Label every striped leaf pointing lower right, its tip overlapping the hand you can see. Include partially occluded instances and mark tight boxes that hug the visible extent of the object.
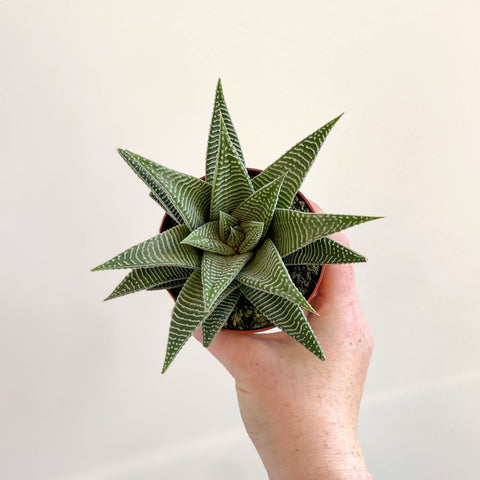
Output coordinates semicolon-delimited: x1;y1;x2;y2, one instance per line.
239;285;325;360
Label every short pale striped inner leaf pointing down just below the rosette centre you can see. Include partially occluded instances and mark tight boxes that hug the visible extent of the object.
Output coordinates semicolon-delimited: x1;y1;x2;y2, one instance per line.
201;252;253;311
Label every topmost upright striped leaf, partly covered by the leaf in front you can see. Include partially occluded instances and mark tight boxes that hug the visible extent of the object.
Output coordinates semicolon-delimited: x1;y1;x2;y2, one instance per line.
205;79;245;184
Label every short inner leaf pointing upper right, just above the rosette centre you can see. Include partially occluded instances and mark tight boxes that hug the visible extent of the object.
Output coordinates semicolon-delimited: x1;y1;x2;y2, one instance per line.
232;177;283;235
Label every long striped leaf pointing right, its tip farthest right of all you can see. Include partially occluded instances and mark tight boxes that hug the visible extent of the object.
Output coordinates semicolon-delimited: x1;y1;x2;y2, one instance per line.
268;209;381;257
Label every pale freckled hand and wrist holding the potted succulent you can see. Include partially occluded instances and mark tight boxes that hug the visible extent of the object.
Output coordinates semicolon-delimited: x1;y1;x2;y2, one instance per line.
195;226;373;480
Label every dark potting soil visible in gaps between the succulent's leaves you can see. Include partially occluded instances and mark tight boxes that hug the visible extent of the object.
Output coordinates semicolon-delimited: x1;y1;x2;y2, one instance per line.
163;194;322;330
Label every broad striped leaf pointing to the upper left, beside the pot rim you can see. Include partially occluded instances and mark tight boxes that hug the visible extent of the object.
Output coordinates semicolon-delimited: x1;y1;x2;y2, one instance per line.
119;150;211;230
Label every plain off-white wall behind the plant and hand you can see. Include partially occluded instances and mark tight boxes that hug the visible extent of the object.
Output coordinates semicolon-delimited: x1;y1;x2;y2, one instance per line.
0;0;480;480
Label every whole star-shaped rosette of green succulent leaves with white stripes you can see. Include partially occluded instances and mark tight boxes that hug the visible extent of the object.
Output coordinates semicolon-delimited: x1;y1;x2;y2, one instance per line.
93;81;379;372
